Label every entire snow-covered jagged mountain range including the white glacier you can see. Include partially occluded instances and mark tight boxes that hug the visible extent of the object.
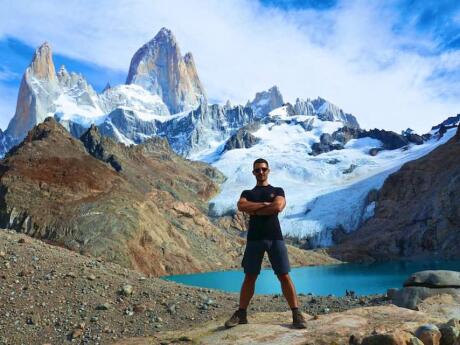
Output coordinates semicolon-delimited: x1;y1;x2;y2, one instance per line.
0;29;452;246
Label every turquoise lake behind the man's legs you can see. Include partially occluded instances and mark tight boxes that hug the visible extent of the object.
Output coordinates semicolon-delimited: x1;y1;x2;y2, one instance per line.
163;260;460;296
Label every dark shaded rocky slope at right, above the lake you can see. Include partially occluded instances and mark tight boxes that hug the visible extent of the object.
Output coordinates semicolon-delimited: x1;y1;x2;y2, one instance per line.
331;125;460;260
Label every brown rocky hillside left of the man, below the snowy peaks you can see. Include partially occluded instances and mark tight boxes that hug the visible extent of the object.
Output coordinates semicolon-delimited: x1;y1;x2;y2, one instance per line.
0;118;243;275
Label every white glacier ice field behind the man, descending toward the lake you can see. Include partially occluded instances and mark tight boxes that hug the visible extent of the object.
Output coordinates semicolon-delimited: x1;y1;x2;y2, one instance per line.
204;113;455;247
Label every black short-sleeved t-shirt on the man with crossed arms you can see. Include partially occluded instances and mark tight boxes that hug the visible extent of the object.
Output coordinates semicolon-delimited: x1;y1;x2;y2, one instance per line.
241;185;284;241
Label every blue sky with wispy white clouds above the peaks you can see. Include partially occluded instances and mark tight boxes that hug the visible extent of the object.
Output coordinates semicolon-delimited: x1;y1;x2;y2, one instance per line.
0;0;460;132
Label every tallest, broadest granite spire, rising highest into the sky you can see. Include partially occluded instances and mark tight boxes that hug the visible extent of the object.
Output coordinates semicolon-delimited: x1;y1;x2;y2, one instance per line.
126;28;206;114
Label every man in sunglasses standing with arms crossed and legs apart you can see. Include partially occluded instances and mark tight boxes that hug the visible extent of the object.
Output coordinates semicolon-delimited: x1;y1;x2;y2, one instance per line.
225;158;306;328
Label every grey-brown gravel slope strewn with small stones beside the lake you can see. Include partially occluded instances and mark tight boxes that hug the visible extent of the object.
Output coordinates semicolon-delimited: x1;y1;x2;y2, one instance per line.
0;230;389;344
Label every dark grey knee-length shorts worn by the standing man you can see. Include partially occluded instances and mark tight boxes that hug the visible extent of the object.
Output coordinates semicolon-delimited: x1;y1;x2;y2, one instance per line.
241;240;291;275
